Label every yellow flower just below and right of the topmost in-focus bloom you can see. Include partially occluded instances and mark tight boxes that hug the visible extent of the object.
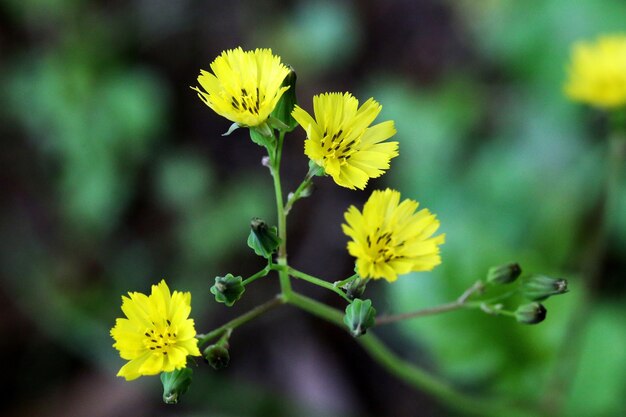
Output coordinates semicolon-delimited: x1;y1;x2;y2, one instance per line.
292;93;398;190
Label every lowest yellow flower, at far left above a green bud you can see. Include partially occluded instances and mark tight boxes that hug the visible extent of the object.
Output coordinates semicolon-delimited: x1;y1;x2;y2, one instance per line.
111;280;200;381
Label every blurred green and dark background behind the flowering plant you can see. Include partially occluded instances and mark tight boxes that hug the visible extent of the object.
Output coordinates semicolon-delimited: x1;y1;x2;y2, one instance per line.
0;0;626;417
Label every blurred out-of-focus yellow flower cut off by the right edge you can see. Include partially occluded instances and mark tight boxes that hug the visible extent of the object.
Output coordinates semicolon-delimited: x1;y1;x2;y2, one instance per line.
565;35;626;109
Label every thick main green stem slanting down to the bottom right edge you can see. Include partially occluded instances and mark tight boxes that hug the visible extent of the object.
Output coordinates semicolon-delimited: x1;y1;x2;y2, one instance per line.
285;293;533;417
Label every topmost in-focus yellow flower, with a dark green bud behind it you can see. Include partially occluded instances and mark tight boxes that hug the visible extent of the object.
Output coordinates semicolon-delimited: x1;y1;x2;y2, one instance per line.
192;48;289;127
